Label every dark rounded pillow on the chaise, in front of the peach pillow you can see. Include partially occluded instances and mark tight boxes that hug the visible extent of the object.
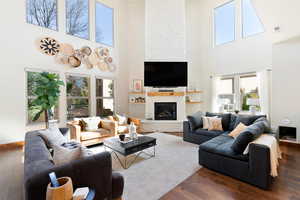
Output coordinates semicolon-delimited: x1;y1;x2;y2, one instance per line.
231;130;254;154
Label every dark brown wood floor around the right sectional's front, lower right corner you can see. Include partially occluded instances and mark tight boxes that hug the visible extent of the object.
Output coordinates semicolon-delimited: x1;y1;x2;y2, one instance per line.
161;145;300;200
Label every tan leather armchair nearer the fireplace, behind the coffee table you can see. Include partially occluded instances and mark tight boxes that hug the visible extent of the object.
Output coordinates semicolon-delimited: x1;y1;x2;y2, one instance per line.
108;116;142;134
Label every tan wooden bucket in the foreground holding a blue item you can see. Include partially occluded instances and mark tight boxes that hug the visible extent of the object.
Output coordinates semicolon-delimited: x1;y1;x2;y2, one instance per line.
46;177;73;200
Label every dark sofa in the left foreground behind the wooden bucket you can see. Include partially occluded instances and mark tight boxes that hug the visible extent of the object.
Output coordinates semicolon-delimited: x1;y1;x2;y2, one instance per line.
24;129;124;200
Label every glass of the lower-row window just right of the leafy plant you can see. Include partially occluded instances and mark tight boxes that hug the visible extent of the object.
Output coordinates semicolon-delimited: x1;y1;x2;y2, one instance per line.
66;75;90;119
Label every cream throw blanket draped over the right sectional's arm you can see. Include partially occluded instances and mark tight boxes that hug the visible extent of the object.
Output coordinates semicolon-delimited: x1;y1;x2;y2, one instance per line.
243;134;281;177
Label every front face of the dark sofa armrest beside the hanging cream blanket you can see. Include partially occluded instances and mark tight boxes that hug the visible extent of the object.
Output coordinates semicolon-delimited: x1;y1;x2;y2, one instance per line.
249;143;271;189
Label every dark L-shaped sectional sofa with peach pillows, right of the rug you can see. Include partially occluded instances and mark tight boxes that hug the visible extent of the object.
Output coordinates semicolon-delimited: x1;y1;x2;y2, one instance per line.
184;113;272;189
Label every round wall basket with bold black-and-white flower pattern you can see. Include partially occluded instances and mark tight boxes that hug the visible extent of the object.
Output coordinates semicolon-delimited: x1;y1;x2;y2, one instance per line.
39;37;60;56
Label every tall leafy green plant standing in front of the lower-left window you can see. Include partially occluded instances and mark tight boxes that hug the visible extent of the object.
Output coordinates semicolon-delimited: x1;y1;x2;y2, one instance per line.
29;72;64;128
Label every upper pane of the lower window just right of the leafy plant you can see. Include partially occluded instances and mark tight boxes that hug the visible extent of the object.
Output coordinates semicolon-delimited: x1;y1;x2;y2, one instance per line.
67;76;89;97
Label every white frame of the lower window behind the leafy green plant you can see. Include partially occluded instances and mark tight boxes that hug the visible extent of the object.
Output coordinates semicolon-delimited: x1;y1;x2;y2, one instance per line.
24;68;60;126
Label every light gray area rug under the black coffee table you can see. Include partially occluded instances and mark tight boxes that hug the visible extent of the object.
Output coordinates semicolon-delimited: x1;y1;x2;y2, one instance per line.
91;133;200;200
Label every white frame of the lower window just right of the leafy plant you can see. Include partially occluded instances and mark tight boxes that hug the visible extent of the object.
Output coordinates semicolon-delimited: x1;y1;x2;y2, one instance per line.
65;73;92;121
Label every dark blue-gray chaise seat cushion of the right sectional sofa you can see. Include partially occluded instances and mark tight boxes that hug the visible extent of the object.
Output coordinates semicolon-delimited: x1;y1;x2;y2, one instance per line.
199;134;249;161
